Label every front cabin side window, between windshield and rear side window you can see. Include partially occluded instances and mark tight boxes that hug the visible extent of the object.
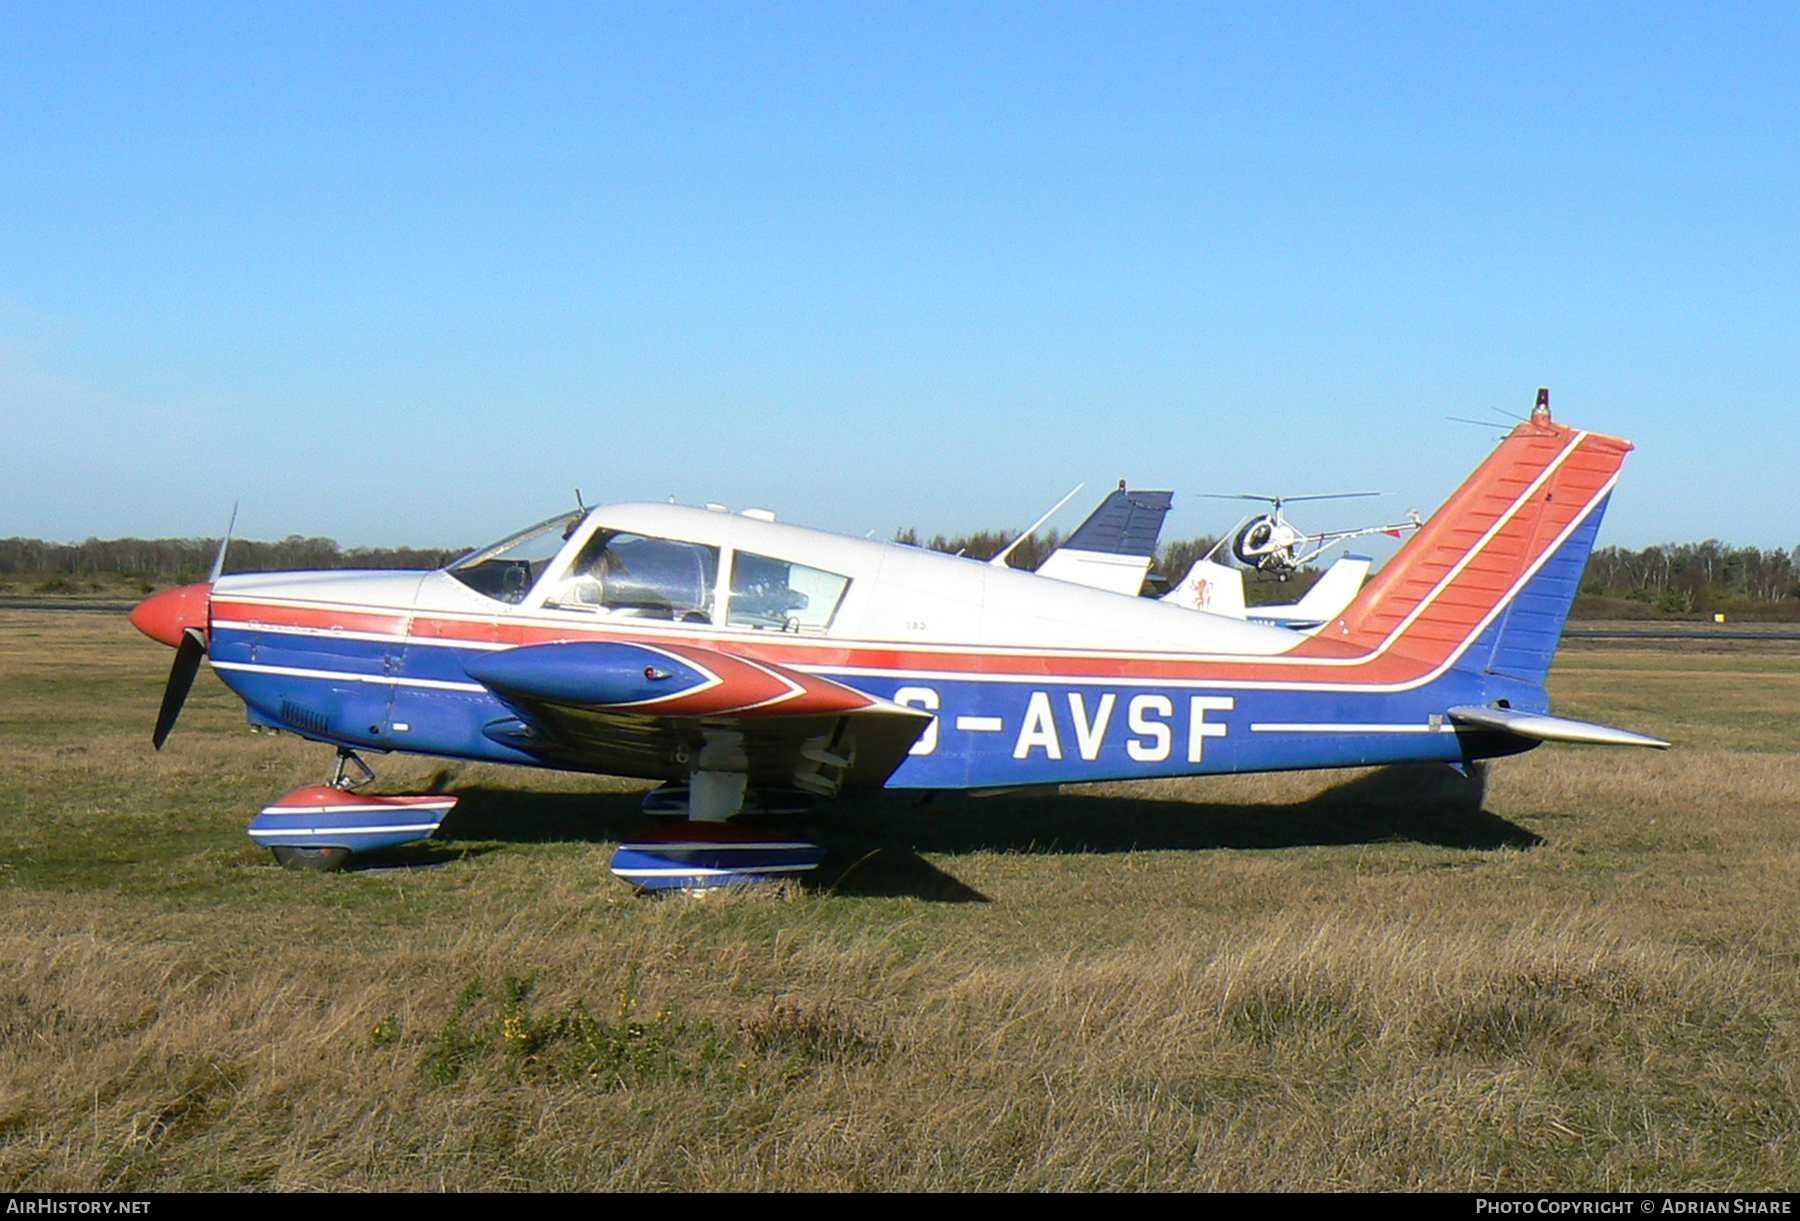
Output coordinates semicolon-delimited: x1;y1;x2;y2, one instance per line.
544;531;718;623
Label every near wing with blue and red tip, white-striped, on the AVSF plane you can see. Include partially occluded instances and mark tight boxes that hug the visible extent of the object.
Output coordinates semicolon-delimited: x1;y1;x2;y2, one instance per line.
466;641;931;794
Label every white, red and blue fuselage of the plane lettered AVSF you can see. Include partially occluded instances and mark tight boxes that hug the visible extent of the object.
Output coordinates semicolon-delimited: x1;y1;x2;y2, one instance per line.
209;499;1576;789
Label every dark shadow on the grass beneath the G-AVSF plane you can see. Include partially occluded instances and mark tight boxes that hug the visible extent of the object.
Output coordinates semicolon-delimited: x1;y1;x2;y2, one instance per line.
409;765;1544;902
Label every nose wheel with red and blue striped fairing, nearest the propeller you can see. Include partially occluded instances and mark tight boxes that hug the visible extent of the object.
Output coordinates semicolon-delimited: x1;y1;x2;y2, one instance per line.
250;747;455;870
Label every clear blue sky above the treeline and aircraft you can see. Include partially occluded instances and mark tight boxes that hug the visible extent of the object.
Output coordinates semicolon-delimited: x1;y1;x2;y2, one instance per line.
0;4;1800;546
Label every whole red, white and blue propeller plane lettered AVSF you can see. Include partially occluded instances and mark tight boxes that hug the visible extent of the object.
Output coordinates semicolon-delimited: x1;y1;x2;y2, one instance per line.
131;391;1667;888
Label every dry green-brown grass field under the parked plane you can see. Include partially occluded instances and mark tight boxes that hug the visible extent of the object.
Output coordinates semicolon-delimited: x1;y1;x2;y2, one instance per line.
0;611;1800;1190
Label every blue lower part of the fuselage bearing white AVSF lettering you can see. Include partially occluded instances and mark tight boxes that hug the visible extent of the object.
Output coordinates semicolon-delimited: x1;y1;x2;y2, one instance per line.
211;615;1548;789
